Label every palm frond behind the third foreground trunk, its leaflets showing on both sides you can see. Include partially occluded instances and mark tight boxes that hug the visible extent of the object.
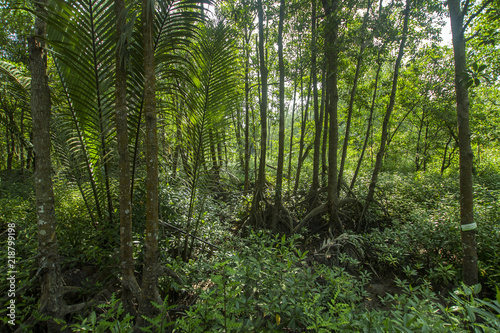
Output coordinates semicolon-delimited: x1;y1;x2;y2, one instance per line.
128;0;209;197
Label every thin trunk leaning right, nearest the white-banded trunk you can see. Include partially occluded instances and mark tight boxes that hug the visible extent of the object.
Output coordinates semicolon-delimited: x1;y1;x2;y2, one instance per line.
358;0;411;232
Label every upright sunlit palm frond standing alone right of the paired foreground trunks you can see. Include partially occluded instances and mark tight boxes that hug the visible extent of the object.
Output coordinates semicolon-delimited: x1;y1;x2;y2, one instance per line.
176;22;238;257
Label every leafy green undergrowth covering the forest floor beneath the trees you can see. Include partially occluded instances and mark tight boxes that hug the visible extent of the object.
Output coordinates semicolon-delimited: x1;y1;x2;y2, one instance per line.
0;166;500;332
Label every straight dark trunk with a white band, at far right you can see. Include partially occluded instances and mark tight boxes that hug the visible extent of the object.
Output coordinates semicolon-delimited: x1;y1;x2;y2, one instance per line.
448;0;478;286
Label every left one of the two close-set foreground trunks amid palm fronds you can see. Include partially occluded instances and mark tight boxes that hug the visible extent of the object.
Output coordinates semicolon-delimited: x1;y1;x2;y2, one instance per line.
115;0;140;313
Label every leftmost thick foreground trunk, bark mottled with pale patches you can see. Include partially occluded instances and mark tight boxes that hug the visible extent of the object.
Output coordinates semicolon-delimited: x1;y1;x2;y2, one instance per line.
29;0;65;326
